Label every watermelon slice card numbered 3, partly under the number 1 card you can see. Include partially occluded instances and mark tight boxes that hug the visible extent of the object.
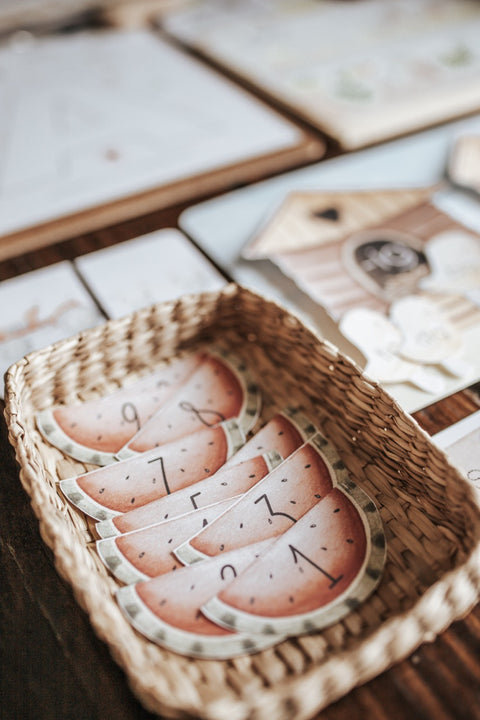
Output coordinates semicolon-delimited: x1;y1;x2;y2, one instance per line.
175;433;347;565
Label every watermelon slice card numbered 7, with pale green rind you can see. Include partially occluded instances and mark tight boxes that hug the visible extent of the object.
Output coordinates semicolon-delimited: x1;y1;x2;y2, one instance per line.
60;420;245;520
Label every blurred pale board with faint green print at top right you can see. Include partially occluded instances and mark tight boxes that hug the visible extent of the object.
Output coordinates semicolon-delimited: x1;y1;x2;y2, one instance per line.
165;0;480;149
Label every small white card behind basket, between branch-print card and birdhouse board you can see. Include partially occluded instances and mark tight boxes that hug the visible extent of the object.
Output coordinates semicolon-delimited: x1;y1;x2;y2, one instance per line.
75;229;227;318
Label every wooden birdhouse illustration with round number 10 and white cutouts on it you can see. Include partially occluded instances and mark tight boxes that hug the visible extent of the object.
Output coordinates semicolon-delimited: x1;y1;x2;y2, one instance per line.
244;188;480;401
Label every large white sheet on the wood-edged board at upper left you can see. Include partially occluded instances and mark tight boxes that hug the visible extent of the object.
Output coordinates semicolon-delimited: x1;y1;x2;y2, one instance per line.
0;31;301;235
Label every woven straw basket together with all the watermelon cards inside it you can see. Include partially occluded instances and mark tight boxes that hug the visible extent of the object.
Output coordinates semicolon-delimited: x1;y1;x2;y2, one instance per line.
5;285;480;720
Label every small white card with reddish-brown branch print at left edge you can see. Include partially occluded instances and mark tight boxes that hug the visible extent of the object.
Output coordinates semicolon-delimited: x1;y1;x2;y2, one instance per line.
0;262;104;395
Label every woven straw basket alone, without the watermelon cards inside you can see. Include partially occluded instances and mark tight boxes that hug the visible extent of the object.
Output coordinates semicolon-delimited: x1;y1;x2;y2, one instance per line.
6;285;480;720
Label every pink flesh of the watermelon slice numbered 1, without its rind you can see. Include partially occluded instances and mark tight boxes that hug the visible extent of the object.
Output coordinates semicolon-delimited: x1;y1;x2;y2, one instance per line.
219;488;367;617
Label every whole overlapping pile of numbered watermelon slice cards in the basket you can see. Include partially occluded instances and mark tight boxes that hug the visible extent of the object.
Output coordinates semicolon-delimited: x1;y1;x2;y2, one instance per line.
37;348;385;658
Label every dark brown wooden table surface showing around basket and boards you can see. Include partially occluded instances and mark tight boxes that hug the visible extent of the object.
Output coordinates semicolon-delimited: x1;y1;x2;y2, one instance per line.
0;143;480;720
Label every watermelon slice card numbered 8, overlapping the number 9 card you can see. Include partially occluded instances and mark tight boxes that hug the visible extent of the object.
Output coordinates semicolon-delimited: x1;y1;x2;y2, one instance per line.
117;350;260;459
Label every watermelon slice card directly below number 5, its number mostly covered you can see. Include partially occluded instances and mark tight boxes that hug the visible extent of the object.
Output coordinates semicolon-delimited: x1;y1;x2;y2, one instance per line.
97;498;234;585
